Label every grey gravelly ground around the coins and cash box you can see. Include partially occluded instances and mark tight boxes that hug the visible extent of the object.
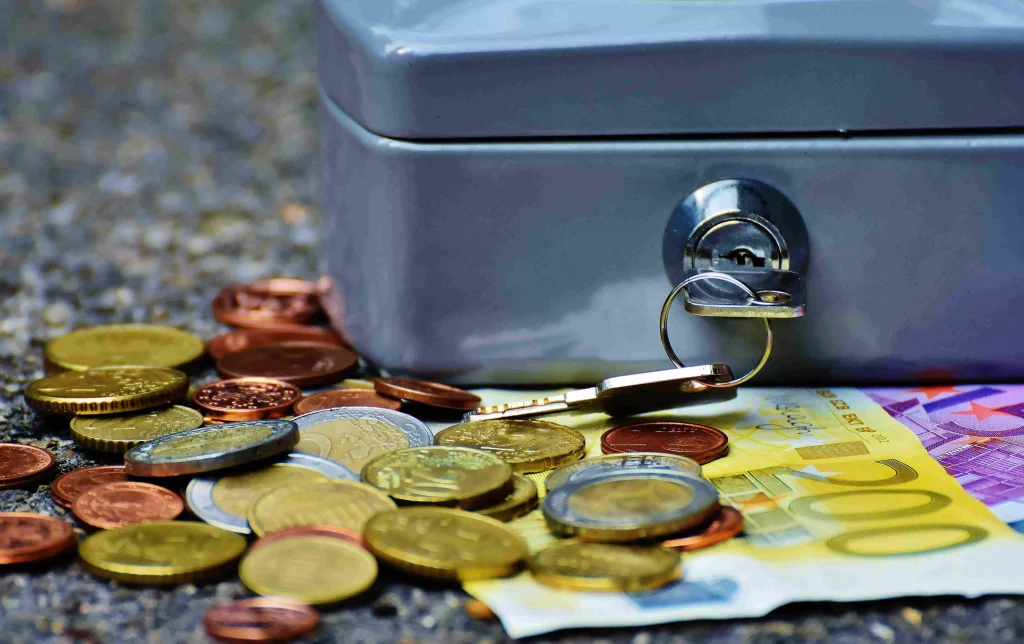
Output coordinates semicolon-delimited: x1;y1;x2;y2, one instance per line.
0;0;1024;644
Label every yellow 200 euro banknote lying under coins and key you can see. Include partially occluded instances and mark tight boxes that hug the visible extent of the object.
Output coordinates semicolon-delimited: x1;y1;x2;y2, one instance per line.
465;388;1024;638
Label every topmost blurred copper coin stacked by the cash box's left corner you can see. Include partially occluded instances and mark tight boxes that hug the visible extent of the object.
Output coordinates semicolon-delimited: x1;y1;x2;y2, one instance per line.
213;277;323;330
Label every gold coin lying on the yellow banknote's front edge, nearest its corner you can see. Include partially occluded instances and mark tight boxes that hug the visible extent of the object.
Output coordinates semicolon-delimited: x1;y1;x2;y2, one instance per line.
526;541;683;593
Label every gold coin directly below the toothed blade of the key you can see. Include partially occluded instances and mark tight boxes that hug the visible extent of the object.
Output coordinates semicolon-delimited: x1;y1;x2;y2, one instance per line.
434;419;586;473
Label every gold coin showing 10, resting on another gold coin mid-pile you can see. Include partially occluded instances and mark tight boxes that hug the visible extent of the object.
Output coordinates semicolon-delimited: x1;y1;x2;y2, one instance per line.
361;445;512;510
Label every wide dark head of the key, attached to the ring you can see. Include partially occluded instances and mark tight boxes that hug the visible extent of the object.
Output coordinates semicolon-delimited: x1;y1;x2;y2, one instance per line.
596;364;736;416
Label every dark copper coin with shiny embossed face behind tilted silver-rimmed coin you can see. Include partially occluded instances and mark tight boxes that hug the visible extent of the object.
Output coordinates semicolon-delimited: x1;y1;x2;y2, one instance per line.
193;378;302;421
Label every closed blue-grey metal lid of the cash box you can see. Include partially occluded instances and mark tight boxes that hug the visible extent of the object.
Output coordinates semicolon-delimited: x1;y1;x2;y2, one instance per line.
317;0;1024;139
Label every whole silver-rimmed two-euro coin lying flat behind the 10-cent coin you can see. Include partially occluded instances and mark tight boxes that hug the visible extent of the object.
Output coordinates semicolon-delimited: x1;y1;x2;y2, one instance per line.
292;407;434;473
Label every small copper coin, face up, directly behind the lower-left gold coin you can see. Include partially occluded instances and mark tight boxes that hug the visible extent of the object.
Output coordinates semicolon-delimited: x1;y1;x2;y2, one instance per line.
71;481;185;530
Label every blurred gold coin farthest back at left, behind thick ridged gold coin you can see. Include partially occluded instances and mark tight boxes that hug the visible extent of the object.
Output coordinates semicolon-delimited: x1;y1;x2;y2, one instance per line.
45;325;204;371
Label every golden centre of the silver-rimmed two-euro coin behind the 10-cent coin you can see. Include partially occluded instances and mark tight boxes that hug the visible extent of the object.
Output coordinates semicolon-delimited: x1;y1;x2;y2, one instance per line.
295;418;409;472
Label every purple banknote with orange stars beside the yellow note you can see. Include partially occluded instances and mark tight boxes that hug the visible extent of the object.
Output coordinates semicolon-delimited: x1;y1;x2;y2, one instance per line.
864;385;1024;532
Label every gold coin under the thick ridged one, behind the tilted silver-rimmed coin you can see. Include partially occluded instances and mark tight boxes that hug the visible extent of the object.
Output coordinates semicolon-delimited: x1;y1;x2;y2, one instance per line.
71;404;203;454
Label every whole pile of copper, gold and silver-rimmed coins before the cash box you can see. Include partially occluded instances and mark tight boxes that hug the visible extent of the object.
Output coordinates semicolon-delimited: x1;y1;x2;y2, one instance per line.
0;280;742;641
